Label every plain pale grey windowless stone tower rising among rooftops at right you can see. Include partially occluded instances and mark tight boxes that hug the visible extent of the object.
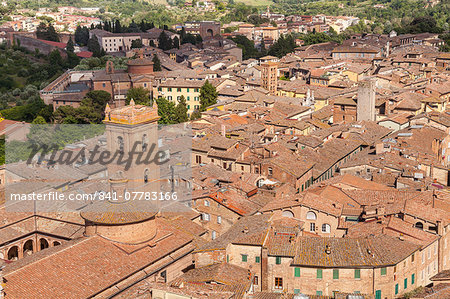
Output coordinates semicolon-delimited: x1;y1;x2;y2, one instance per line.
356;79;376;121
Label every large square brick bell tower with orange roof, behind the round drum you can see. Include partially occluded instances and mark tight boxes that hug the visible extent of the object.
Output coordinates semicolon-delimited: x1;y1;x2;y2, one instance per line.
103;100;160;193
